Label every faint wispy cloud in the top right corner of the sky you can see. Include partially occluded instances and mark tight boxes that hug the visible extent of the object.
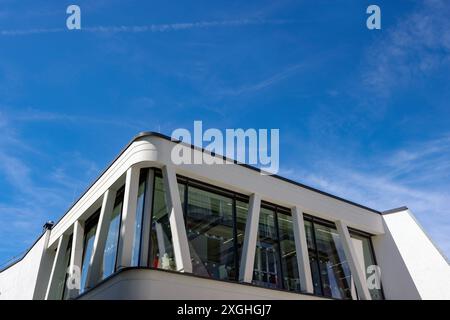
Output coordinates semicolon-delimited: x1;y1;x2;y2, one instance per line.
362;0;450;97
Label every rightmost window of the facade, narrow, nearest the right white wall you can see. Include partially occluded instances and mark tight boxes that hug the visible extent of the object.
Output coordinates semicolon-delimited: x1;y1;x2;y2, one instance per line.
350;232;384;300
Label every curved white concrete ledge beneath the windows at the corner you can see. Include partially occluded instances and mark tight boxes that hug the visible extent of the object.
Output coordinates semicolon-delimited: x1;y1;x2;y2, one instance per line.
78;268;328;300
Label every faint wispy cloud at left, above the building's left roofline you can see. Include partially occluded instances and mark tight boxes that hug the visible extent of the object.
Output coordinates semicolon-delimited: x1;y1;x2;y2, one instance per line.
0;112;99;266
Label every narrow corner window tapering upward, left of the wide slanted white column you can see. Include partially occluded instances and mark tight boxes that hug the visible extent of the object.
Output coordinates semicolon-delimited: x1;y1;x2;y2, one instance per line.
149;175;176;270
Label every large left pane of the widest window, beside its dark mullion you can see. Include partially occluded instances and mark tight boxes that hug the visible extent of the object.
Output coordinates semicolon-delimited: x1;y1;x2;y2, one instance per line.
186;186;237;280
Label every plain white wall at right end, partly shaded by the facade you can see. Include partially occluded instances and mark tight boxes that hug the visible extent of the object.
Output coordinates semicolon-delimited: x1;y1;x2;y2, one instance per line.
373;209;450;300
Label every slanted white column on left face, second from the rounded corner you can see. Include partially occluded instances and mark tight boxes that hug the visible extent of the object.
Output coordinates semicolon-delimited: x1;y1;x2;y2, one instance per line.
86;189;117;288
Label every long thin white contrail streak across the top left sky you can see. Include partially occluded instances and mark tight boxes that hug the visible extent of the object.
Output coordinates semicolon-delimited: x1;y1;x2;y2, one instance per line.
0;19;293;36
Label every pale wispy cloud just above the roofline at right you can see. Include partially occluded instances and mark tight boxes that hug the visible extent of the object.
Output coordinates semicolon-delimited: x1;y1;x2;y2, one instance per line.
282;136;450;257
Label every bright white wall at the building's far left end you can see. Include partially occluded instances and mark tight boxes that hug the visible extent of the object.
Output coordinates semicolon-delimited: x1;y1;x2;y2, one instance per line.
0;235;46;300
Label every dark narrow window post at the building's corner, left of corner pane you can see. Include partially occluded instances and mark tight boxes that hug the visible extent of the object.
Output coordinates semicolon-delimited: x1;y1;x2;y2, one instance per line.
139;169;155;267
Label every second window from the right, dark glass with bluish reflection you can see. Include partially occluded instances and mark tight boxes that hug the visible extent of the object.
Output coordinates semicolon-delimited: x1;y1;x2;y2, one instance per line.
305;219;354;299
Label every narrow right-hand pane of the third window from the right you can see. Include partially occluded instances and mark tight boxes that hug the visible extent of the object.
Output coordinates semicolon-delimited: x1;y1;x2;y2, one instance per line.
277;212;301;292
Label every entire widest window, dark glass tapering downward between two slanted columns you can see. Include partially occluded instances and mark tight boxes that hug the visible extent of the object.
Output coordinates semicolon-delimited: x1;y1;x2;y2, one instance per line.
178;178;248;281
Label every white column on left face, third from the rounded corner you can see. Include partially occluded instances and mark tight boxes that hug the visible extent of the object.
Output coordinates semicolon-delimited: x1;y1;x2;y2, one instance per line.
68;220;84;299
